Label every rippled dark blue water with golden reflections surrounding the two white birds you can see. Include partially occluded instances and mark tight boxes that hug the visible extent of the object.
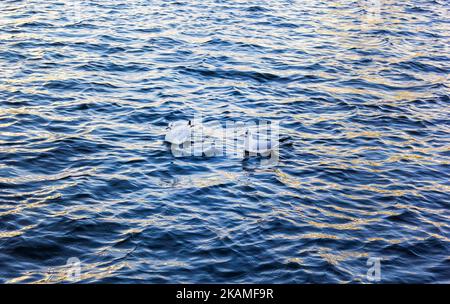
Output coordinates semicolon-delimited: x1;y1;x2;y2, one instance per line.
0;0;450;283
